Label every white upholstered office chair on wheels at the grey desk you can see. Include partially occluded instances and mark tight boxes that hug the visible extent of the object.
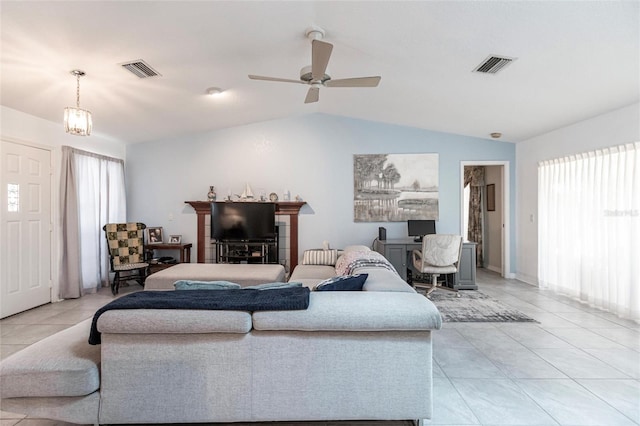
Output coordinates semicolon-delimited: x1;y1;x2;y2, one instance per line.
412;234;462;297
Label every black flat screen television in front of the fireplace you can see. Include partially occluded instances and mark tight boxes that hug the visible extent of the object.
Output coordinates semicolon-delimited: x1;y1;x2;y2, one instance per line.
211;202;276;241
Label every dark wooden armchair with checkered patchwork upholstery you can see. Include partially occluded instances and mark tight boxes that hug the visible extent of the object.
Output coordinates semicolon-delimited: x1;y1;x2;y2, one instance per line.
102;222;149;296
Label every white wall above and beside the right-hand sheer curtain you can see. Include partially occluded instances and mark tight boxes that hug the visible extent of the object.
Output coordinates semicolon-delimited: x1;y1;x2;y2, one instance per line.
516;104;640;284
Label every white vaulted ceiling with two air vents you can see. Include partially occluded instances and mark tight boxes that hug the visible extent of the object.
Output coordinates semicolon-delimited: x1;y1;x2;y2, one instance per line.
0;1;640;143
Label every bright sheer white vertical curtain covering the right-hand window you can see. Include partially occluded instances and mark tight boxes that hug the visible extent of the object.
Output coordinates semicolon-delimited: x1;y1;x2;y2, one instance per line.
538;142;640;322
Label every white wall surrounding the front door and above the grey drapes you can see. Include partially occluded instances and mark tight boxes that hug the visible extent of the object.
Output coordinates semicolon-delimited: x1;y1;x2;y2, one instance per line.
0;105;126;300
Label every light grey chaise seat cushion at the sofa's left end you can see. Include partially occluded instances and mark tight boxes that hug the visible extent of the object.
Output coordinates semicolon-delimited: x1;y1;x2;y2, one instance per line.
0;319;100;398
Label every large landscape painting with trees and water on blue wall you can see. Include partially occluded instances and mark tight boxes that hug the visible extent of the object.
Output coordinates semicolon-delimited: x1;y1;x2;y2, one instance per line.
353;154;438;222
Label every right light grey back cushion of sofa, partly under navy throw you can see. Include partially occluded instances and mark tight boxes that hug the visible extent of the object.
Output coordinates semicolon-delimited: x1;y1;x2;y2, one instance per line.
252;291;442;331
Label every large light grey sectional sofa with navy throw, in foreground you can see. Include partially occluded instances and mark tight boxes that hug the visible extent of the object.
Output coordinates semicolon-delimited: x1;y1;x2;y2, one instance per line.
0;245;441;424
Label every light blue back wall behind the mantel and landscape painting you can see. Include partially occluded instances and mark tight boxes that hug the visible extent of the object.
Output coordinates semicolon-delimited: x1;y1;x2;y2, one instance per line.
126;114;516;271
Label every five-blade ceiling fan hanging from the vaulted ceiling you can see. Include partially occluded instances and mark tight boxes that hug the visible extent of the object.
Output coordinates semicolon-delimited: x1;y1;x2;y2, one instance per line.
249;27;381;104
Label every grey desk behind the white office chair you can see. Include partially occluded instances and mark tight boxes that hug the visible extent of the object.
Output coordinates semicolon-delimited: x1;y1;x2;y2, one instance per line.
373;238;478;290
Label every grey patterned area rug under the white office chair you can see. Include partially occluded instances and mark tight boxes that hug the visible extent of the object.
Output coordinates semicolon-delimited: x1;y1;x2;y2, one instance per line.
418;289;538;322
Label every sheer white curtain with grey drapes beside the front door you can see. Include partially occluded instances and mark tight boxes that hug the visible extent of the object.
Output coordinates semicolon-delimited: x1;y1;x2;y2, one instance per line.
60;147;126;298
